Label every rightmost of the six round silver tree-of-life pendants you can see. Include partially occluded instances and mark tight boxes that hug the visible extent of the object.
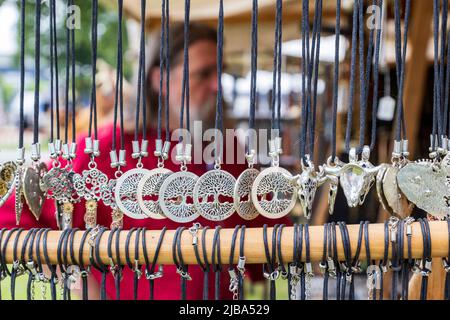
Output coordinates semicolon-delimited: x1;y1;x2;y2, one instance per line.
252;167;297;219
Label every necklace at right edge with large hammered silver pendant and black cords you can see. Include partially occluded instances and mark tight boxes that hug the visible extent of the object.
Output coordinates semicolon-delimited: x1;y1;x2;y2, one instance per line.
397;0;450;218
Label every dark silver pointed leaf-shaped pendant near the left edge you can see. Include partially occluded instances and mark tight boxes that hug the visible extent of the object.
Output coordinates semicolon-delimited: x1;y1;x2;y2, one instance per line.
23;162;47;220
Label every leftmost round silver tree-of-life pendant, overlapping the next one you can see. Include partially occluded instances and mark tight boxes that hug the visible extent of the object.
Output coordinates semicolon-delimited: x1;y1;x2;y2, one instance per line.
114;168;149;220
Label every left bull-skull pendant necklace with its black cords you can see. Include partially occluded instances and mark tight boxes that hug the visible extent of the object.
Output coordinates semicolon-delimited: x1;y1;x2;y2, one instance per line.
292;0;338;219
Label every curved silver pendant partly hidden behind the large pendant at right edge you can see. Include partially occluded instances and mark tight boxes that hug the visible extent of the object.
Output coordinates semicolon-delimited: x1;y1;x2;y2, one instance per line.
377;165;414;218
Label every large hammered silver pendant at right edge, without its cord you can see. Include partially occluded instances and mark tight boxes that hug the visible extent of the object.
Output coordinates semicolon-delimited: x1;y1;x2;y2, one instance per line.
397;160;450;218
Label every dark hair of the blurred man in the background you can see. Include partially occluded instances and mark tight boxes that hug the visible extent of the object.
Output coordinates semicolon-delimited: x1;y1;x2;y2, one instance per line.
146;22;217;124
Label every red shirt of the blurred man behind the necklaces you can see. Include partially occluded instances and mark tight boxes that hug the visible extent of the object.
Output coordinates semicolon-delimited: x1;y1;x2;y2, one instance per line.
0;126;290;300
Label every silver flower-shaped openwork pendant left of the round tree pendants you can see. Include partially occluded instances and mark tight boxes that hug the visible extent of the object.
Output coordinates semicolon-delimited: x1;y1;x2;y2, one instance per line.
72;167;108;201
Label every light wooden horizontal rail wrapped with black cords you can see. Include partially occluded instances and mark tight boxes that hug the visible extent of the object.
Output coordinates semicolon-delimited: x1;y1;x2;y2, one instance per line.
2;221;449;265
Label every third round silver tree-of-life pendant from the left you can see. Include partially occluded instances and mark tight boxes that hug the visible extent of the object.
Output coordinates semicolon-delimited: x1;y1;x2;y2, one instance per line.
158;171;200;223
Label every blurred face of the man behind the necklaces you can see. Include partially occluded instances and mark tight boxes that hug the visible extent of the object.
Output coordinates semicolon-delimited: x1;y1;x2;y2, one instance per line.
170;40;217;129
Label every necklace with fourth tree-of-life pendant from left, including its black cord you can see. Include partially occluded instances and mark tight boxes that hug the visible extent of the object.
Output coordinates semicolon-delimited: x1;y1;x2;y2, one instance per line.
194;0;236;221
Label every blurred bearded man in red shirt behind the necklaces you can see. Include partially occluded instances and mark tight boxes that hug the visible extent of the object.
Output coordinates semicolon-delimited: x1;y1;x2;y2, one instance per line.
0;23;289;300
